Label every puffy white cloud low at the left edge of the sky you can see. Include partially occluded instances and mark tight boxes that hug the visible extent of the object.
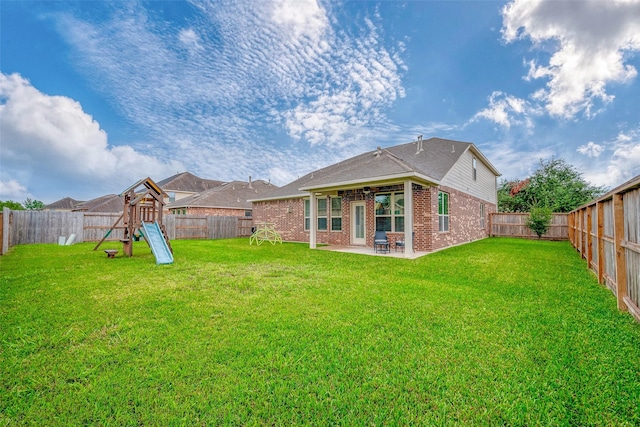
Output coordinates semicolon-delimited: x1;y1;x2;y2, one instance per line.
0;73;183;201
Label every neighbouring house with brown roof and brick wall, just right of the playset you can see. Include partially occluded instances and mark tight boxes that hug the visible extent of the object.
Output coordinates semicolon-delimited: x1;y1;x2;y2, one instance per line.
165;177;278;218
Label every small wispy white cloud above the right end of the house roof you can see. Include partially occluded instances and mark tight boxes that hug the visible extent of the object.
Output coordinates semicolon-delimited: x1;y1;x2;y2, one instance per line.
471;91;540;129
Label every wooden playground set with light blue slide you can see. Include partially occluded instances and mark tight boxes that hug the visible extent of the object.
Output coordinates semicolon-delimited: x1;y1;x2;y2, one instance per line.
93;178;173;264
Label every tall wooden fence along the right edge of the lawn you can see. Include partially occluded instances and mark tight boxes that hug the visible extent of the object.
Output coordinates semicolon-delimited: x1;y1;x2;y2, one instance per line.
569;175;640;322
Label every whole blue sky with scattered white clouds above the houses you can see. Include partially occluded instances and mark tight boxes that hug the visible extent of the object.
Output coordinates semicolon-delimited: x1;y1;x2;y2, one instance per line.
0;0;640;203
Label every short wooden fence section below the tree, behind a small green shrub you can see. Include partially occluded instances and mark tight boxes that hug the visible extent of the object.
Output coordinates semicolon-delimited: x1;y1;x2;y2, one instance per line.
489;212;569;240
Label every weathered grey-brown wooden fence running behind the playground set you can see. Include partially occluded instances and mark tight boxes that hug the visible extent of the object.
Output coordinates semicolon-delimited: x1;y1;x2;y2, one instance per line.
0;208;252;254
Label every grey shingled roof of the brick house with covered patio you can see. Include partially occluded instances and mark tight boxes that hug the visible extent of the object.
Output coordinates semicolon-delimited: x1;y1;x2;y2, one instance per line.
253;138;500;201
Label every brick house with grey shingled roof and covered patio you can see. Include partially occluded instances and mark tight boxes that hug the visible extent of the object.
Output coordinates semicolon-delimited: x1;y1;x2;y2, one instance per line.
252;137;500;256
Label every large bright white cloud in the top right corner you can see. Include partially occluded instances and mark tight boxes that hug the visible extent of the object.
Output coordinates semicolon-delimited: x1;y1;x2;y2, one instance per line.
502;0;640;118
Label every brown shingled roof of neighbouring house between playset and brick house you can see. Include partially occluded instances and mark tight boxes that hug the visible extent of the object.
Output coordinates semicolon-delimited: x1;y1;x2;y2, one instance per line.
165;180;277;209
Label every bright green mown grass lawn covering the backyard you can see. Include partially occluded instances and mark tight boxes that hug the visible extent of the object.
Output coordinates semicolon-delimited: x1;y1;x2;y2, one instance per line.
0;239;640;426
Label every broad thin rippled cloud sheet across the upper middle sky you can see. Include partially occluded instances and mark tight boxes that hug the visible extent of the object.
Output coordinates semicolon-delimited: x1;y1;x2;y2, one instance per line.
57;0;406;154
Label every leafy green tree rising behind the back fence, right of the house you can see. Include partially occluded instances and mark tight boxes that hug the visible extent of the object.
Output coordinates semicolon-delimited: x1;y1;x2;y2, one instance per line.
498;159;607;212
